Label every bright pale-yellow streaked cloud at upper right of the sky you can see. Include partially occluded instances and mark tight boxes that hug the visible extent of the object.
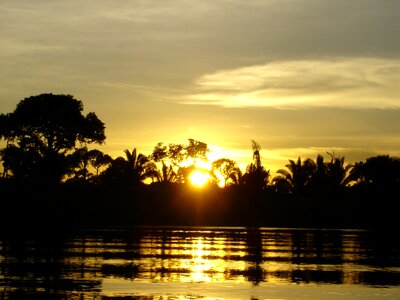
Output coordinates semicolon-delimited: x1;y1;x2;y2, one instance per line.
182;58;400;108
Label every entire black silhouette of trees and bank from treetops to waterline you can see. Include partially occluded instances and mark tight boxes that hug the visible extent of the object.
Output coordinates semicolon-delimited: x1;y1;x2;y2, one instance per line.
0;94;400;229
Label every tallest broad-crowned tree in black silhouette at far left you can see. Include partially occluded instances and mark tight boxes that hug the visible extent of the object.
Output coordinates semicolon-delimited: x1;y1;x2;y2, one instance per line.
0;94;105;183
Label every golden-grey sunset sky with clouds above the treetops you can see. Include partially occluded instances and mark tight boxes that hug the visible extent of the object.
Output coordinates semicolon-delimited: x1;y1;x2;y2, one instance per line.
0;0;400;172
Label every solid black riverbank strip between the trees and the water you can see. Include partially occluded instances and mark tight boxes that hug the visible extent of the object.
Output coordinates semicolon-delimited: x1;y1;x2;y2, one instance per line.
0;180;400;231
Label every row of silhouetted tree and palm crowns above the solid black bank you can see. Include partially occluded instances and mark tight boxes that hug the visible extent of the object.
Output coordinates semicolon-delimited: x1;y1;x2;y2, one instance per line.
0;94;400;195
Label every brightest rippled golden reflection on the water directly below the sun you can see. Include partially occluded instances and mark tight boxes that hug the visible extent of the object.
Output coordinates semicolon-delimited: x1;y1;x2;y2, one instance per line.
140;234;246;282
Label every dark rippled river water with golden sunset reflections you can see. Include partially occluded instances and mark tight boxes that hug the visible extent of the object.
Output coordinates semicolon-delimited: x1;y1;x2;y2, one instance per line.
0;227;400;300
